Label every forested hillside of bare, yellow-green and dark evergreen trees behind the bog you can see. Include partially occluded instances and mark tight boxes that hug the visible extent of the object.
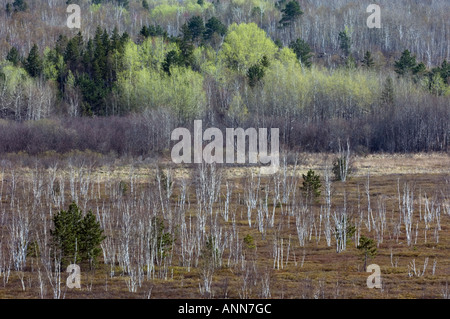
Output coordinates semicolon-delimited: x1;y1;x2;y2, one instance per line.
0;0;450;156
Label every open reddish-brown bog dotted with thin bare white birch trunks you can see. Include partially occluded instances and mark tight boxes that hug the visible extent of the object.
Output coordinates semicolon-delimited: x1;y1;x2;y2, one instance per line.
0;153;450;299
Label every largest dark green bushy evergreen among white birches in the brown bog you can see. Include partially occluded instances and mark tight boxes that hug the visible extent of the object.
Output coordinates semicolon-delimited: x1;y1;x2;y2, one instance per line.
50;203;106;267
